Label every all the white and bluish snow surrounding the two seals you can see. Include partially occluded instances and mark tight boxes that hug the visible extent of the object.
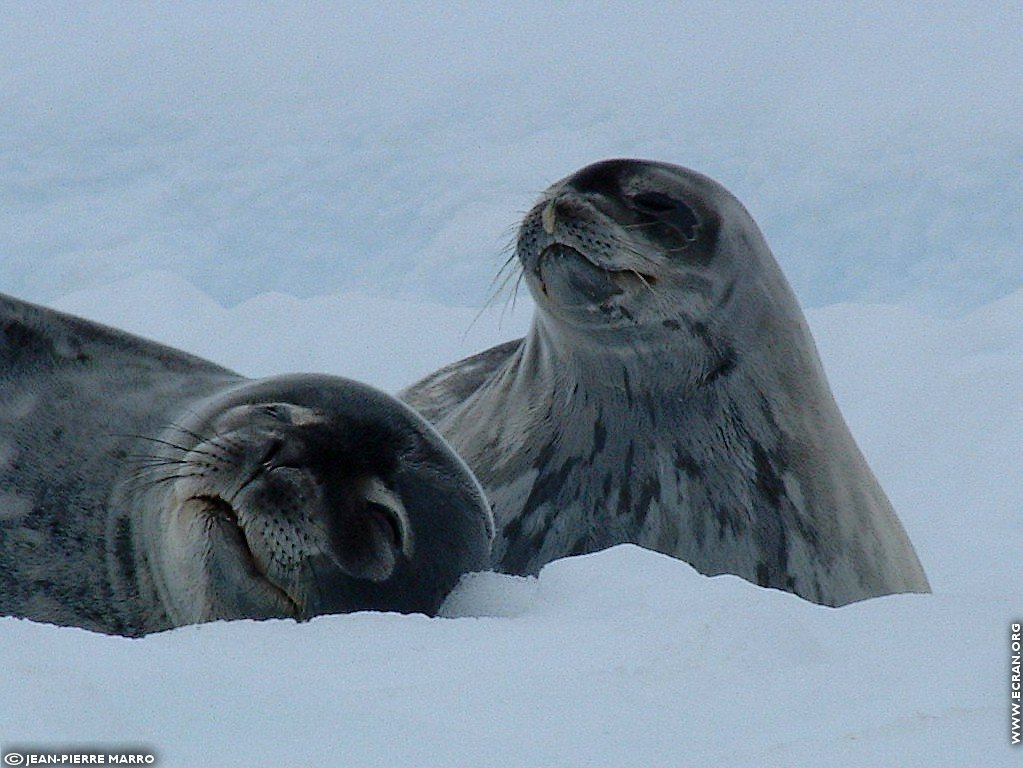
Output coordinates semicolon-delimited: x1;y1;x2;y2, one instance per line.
0;2;1023;768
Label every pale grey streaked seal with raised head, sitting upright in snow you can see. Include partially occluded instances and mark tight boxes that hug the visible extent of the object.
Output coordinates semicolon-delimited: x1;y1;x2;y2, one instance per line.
399;160;930;605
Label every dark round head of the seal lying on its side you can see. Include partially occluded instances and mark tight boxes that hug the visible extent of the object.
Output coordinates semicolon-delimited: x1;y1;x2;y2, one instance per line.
110;375;492;625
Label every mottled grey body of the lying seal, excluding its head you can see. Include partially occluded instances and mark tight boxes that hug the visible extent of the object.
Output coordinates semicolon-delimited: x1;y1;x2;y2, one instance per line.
0;295;243;632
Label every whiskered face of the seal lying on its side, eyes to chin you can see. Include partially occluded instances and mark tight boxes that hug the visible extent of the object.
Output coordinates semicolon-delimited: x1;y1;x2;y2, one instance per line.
155;403;427;618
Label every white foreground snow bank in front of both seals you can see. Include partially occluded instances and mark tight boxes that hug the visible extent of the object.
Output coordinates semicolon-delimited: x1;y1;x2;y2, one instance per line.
2;546;1009;766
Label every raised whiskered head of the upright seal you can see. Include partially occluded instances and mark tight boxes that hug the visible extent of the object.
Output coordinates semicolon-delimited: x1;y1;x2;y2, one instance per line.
517;161;720;346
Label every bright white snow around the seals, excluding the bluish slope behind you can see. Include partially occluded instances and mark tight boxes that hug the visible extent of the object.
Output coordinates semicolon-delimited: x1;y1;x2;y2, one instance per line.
0;274;1023;768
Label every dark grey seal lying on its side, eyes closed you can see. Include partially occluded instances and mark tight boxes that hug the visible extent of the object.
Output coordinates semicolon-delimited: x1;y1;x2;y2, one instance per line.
0;296;493;636
